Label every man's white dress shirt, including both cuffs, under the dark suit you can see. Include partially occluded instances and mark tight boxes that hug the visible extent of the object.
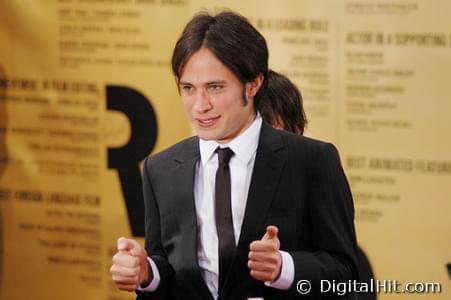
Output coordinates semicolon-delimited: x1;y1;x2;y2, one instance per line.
140;114;294;299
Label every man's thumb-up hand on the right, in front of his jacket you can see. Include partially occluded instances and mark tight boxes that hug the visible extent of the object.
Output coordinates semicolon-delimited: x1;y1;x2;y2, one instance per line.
247;225;282;282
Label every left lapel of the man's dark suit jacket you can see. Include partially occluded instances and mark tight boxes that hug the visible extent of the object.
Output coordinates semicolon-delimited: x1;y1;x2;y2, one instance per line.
172;138;216;299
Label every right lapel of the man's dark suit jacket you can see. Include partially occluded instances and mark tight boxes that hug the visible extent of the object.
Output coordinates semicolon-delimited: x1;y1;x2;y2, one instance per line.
224;122;283;290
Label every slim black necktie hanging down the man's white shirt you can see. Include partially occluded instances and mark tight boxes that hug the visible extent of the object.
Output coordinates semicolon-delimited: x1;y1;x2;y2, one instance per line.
215;147;235;291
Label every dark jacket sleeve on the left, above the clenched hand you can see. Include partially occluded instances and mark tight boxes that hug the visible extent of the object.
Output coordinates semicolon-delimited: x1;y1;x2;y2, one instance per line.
137;158;174;300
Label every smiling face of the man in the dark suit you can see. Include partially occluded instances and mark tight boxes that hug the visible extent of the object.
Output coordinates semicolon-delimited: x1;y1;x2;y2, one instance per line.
179;48;262;143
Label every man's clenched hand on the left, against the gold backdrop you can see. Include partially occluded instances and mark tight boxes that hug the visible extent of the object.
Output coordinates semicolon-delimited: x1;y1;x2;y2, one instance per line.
110;237;153;291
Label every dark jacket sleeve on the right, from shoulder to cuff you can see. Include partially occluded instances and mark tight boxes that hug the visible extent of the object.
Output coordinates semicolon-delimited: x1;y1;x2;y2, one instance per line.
290;144;358;296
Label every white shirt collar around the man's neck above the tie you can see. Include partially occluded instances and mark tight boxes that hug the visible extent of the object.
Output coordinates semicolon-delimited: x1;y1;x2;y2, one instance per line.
199;113;262;165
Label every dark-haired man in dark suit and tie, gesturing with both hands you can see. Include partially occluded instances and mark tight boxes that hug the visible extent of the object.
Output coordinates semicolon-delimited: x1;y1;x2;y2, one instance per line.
111;13;357;299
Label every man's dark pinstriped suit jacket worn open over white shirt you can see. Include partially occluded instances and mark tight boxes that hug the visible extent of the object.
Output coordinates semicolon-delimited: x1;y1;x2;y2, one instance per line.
138;123;358;299
